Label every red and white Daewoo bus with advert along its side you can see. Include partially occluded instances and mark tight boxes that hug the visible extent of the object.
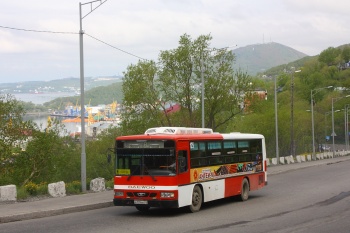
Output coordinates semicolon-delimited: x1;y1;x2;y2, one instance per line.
113;127;267;212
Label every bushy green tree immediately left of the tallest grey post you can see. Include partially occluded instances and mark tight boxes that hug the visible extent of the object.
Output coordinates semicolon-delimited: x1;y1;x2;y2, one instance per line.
13;118;77;185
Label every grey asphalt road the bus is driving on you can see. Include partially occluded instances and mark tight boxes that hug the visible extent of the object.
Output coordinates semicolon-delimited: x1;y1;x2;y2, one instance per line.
0;160;350;233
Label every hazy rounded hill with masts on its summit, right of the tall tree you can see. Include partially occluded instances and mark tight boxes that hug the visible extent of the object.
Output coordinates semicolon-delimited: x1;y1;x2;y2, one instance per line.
232;42;308;76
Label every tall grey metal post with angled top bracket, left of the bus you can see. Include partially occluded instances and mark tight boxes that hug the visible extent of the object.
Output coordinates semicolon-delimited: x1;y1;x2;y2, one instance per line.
79;0;107;192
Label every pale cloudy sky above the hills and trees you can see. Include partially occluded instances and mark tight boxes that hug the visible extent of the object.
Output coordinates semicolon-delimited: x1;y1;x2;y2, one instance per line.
0;0;350;83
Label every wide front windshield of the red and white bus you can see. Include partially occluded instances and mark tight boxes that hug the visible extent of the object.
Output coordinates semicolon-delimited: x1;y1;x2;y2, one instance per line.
116;148;176;177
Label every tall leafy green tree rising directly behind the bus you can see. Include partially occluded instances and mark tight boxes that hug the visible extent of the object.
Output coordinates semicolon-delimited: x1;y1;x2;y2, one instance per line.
123;34;251;132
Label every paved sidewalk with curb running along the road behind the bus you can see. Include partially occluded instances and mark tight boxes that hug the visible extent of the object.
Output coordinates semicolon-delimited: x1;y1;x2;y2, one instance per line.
0;156;350;224
